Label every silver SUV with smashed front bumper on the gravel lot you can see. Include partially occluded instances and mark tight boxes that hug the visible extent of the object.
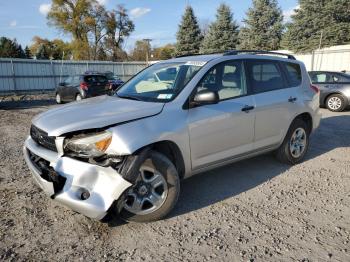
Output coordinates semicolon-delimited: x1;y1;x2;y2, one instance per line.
24;51;320;222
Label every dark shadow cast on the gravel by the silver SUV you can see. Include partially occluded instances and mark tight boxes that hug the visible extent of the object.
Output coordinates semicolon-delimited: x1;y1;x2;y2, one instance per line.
170;115;350;217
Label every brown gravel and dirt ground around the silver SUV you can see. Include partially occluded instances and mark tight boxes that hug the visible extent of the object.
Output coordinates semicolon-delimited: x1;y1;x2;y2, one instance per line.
0;101;350;261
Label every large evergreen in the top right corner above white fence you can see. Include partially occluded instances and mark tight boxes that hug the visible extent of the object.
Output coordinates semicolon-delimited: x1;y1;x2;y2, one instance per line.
282;0;350;52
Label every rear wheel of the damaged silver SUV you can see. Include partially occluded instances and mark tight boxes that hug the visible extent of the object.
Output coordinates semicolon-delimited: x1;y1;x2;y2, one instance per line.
276;118;310;165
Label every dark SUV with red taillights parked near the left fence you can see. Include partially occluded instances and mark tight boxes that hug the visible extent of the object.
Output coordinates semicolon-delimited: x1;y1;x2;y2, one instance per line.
56;74;110;104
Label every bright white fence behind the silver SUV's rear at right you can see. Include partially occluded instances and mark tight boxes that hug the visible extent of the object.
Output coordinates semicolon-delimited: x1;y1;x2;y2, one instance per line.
279;45;350;72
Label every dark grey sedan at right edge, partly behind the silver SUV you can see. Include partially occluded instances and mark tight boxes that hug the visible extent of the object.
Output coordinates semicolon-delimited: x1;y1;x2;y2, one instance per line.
309;71;350;112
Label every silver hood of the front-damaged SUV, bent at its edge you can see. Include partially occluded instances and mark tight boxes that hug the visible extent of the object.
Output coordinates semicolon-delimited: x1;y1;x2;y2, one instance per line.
33;96;164;136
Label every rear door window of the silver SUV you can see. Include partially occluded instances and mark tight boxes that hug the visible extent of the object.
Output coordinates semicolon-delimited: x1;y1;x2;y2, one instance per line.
247;60;285;93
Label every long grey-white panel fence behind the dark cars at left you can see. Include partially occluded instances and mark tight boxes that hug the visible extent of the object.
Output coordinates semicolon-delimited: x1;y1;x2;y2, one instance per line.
0;58;146;94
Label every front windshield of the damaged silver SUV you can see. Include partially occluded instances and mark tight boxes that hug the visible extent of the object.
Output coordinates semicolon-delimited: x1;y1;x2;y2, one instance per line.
117;62;204;102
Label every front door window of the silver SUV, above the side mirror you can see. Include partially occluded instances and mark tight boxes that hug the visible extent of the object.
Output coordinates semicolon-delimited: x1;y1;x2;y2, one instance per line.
197;61;247;100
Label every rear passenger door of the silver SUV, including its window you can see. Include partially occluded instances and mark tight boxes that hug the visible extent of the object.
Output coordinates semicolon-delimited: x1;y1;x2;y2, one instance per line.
247;59;302;150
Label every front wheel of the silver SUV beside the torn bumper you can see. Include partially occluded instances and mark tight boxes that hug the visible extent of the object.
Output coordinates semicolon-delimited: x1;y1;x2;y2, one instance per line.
118;150;180;222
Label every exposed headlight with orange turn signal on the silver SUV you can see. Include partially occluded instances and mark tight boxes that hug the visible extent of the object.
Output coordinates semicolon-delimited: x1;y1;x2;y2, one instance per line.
64;131;112;157
